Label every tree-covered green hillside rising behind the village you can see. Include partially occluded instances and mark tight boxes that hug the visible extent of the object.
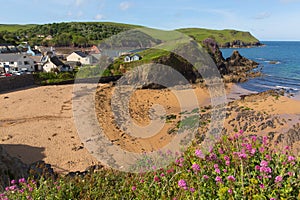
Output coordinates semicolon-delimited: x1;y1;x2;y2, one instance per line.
0;22;139;47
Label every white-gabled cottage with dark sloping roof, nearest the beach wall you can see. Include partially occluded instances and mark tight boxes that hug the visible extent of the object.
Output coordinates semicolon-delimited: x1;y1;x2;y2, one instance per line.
42;56;72;72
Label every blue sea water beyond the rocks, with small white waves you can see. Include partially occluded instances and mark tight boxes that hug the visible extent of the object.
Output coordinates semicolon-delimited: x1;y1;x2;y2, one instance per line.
221;41;300;93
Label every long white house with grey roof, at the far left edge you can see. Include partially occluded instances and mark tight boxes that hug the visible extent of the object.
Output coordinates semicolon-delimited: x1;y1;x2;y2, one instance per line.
0;53;35;72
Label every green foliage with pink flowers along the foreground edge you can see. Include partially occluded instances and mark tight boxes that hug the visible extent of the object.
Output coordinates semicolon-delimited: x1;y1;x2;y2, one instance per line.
0;131;300;200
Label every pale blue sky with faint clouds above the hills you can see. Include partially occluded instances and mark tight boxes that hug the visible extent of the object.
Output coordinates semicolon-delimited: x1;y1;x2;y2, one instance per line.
0;0;300;41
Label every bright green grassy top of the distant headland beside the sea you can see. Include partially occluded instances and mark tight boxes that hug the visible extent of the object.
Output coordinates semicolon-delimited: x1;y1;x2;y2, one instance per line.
177;28;259;45
